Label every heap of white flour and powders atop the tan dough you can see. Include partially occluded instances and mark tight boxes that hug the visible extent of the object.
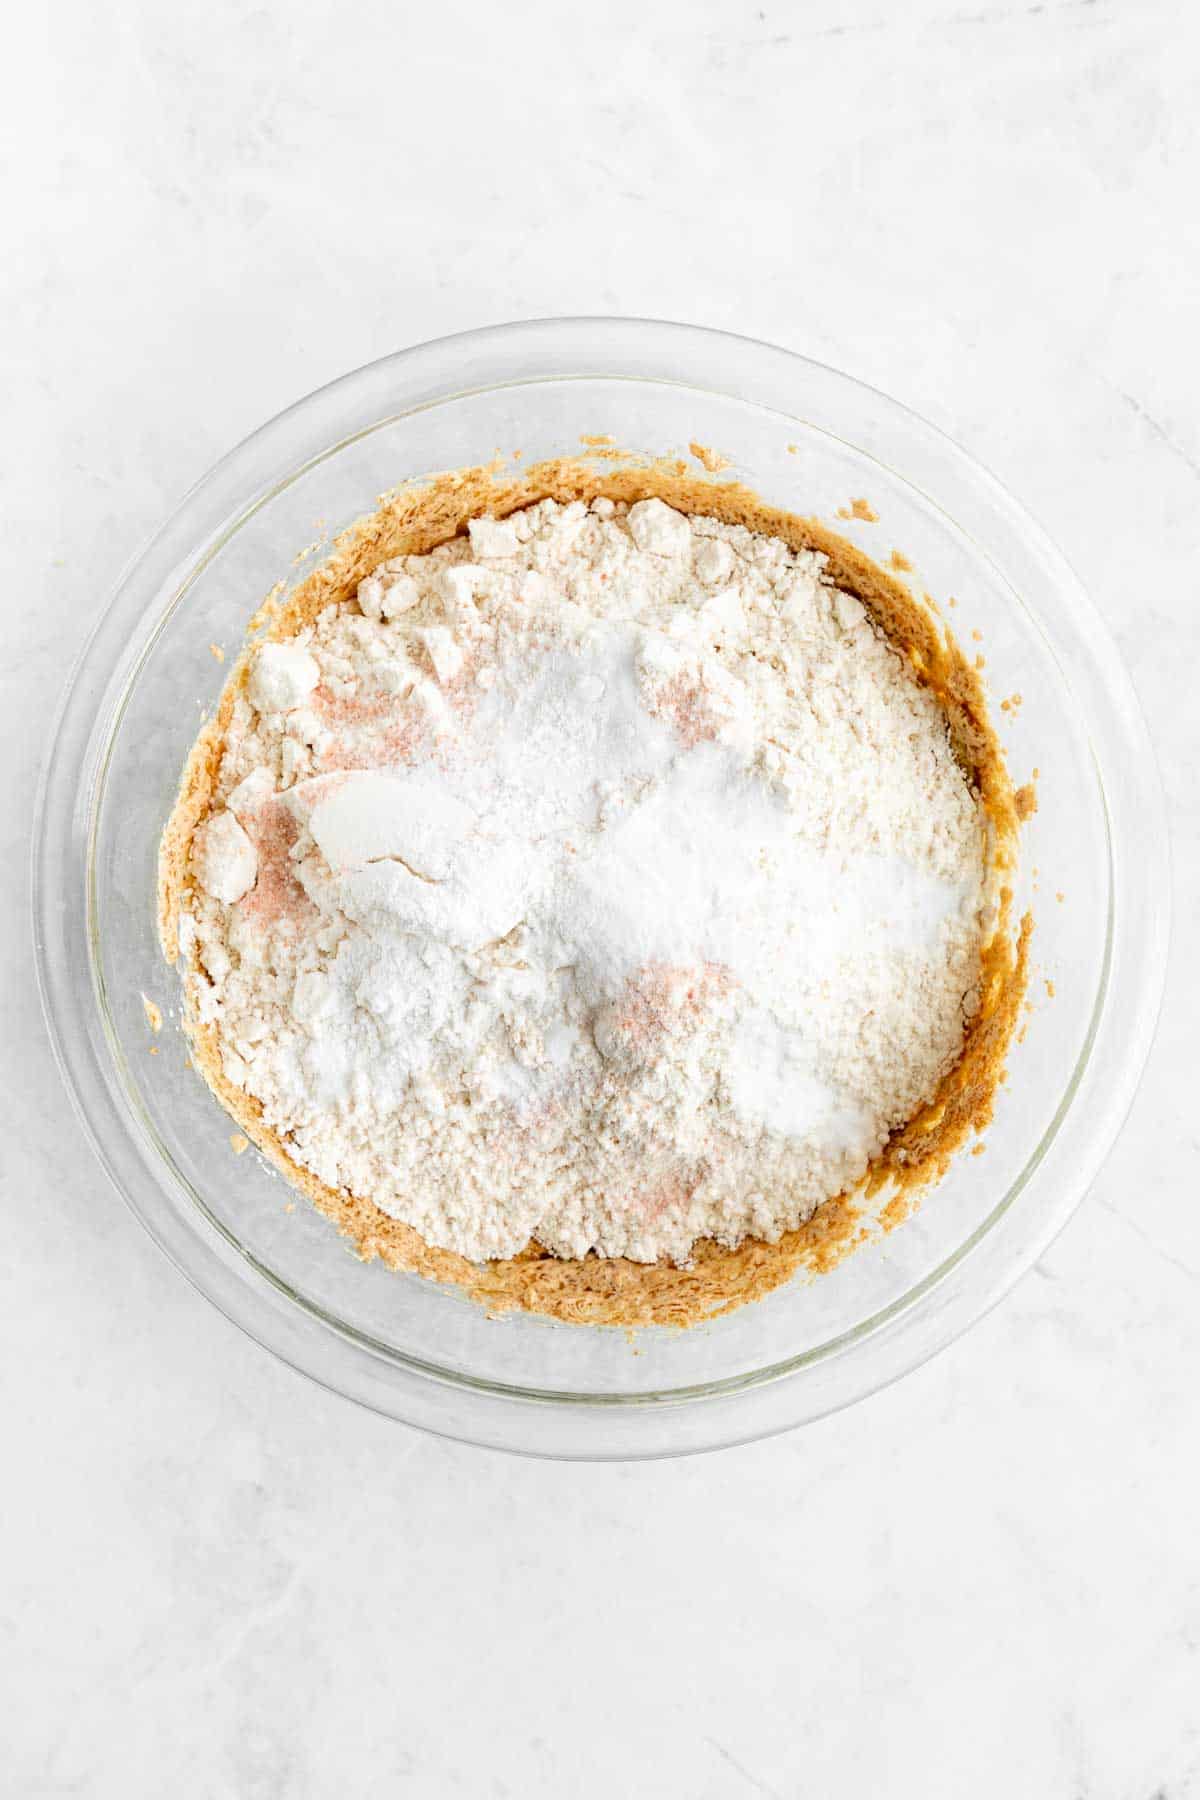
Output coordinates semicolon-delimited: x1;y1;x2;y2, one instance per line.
182;500;986;1262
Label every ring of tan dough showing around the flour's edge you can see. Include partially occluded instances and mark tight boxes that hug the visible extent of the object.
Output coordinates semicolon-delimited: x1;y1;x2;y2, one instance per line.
158;445;1031;1327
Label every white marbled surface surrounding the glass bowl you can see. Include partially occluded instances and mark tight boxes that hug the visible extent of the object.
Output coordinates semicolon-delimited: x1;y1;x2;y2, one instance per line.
9;0;1200;1800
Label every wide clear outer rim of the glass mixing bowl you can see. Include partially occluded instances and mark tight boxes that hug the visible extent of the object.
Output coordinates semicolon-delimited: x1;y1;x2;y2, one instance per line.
31;317;1169;1458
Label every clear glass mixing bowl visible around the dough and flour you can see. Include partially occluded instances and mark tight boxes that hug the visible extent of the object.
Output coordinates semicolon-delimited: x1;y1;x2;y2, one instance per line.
34;319;1168;1458
